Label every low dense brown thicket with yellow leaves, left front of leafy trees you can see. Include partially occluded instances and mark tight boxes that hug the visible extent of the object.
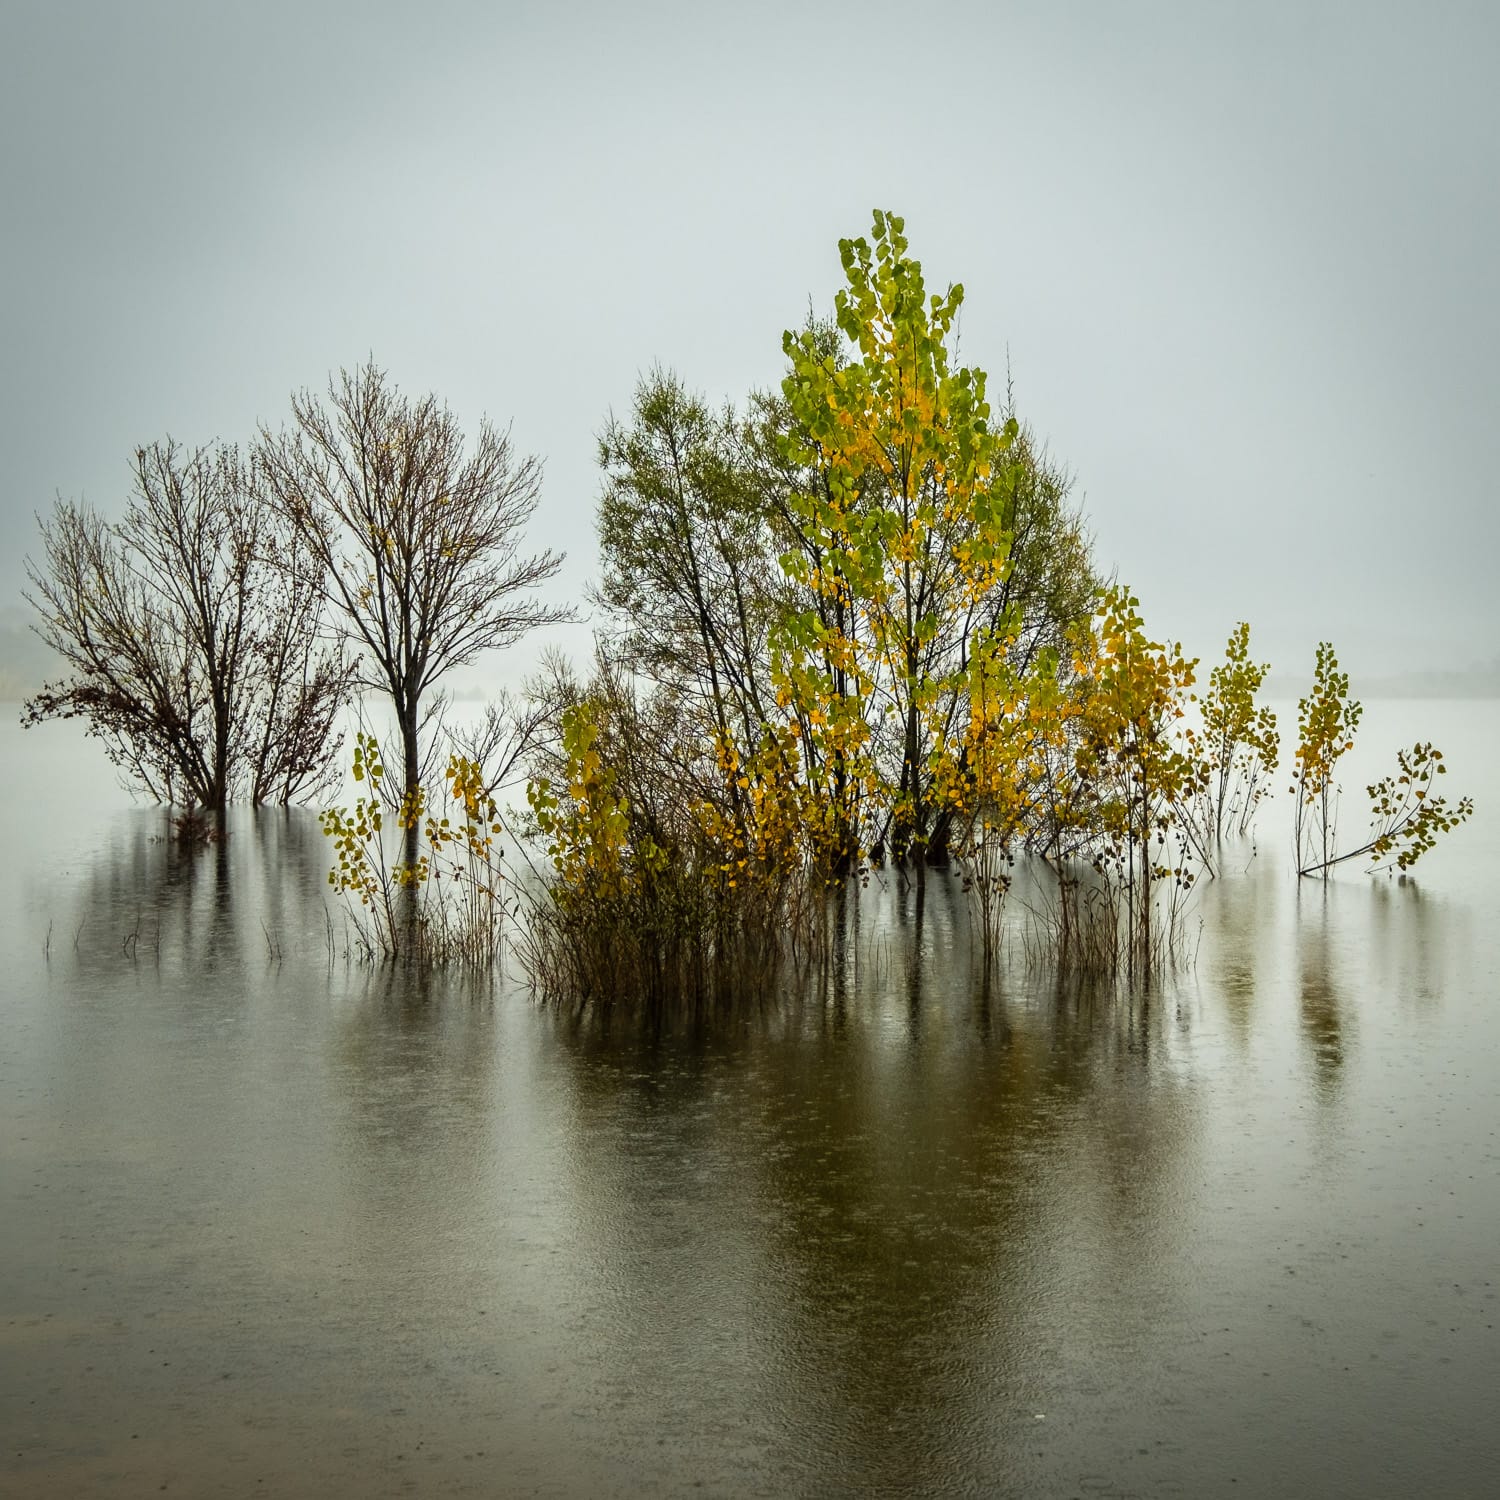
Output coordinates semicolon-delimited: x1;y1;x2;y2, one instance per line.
525;660;806;1004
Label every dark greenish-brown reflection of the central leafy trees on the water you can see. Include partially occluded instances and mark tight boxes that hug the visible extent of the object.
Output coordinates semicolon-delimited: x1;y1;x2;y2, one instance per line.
546;876;1188;1493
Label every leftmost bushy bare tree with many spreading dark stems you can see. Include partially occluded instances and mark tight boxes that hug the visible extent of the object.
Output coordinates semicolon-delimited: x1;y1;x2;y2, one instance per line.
24;440;350;812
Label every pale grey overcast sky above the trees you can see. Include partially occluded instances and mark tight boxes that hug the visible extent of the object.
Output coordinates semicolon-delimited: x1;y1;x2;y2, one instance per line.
0;0;1500;692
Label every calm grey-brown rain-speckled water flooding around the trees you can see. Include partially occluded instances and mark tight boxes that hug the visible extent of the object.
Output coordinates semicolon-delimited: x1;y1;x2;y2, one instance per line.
0;704;1500;1497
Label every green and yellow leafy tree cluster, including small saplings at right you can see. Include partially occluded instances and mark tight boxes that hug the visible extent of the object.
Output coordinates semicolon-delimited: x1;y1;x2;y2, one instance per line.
531;213;1469;995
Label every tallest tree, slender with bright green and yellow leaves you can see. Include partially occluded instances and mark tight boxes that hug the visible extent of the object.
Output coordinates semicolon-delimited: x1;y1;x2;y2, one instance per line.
774;212;1017;870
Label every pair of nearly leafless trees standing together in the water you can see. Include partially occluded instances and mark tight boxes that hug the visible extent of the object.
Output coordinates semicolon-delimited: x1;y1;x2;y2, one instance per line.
23;363;566;813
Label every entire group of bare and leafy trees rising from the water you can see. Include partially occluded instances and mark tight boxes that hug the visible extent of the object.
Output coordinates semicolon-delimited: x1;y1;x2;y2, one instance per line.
27;213;1470;998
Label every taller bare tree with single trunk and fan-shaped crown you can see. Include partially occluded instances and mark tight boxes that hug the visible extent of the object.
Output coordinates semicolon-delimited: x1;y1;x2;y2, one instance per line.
261;363;572;791
